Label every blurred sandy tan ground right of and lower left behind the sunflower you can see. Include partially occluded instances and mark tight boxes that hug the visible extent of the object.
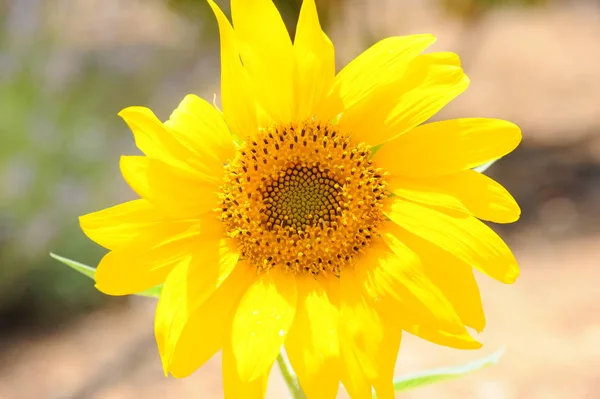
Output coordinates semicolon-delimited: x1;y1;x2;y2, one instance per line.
0;0;600;399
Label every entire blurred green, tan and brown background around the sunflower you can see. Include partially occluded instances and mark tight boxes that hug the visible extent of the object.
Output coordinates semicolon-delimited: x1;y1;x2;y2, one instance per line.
0;0;600;399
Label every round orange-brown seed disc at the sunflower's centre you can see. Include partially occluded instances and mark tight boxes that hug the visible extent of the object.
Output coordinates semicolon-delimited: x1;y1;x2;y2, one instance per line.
218;122;386;276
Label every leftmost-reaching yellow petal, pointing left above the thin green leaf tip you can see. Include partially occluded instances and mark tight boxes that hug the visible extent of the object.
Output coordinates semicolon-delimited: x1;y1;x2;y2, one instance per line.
79;199;172;249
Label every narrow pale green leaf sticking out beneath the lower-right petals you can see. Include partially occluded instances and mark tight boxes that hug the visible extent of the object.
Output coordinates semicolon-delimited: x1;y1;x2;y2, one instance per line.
394;348;504;392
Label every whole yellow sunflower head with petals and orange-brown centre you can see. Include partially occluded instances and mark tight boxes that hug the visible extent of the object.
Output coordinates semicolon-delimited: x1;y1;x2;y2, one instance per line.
81;0;521;399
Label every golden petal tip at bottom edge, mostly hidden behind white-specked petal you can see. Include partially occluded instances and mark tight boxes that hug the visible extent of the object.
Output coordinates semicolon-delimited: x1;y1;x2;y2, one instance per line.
222;343;273;399
